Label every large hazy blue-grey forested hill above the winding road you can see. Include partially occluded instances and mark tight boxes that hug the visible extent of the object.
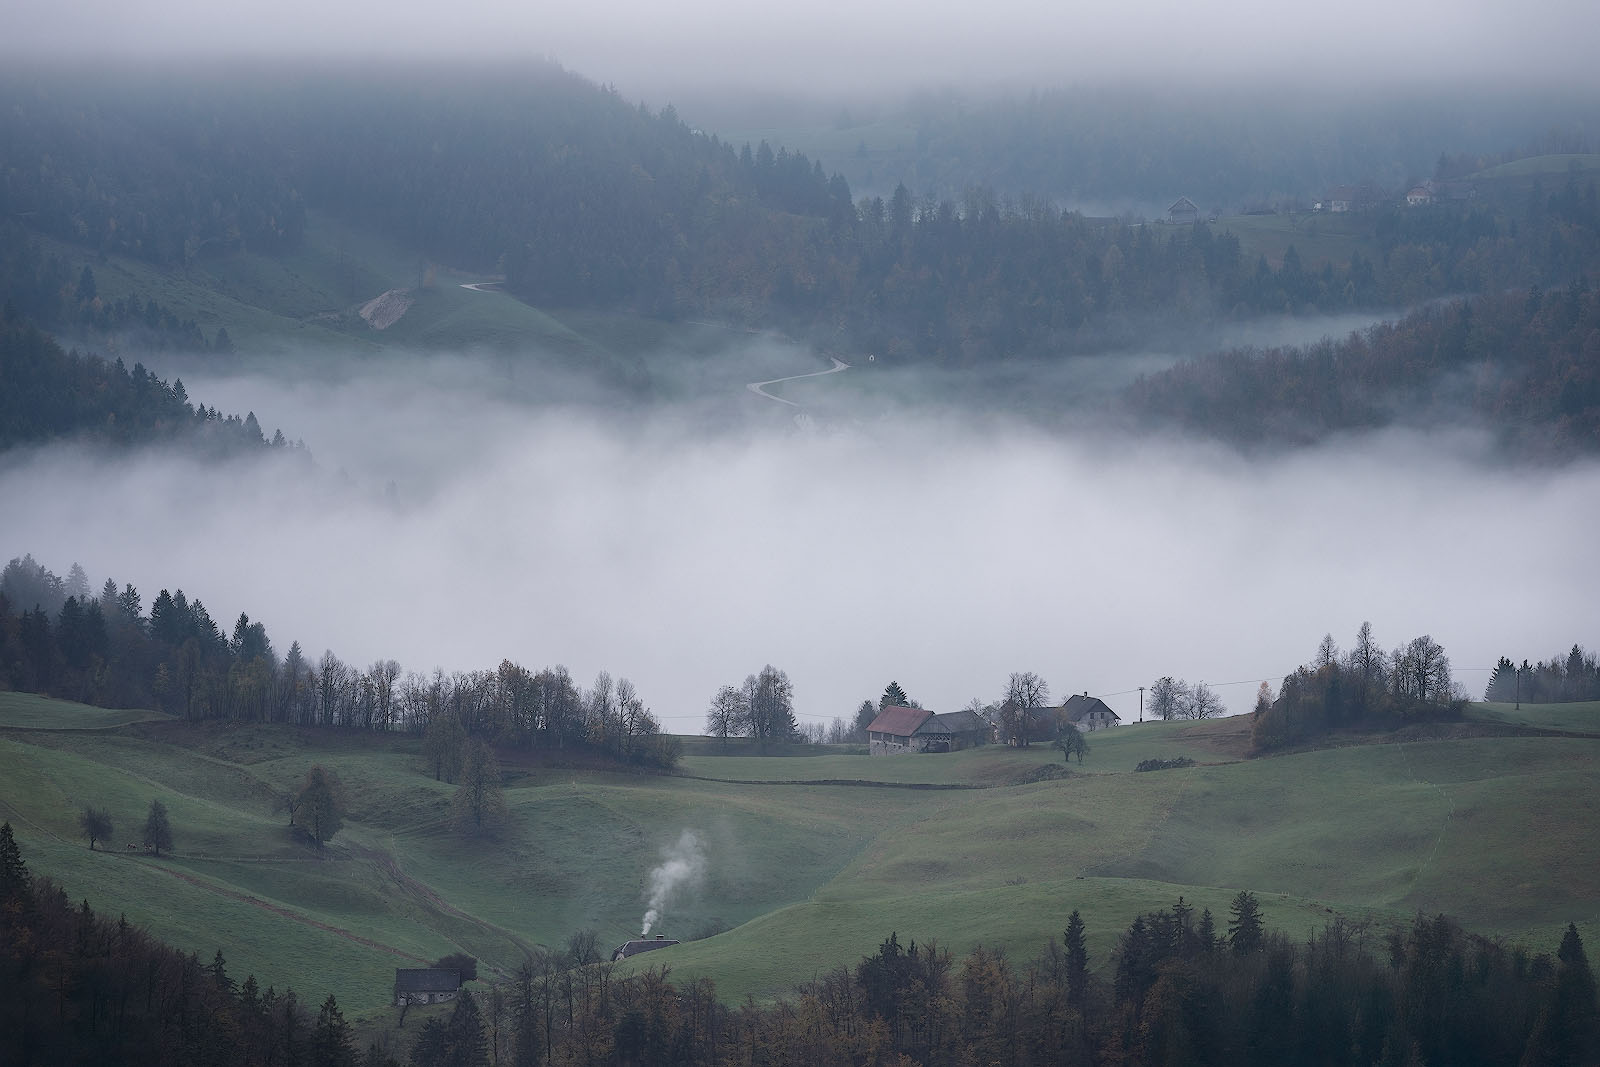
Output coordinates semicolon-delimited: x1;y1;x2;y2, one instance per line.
9;64;1600;375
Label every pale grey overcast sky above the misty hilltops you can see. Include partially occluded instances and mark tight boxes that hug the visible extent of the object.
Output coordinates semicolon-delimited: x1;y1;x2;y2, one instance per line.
12;0;1600;94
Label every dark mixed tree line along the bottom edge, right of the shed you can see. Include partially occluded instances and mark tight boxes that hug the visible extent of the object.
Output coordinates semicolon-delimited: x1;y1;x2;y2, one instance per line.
411;891;1600;1067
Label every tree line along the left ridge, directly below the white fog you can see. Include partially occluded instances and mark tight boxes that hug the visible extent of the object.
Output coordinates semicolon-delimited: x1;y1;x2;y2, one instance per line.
0;555;678;781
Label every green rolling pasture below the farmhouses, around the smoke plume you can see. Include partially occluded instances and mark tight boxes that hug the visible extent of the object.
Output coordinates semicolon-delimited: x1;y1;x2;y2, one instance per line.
0;697;1600;1022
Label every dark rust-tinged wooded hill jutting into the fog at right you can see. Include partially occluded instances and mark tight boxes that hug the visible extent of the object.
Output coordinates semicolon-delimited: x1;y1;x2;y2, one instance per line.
1125;282;1600;458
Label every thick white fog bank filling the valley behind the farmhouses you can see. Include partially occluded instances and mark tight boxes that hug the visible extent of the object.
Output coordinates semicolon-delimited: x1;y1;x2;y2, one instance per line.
0;348;1600;731
